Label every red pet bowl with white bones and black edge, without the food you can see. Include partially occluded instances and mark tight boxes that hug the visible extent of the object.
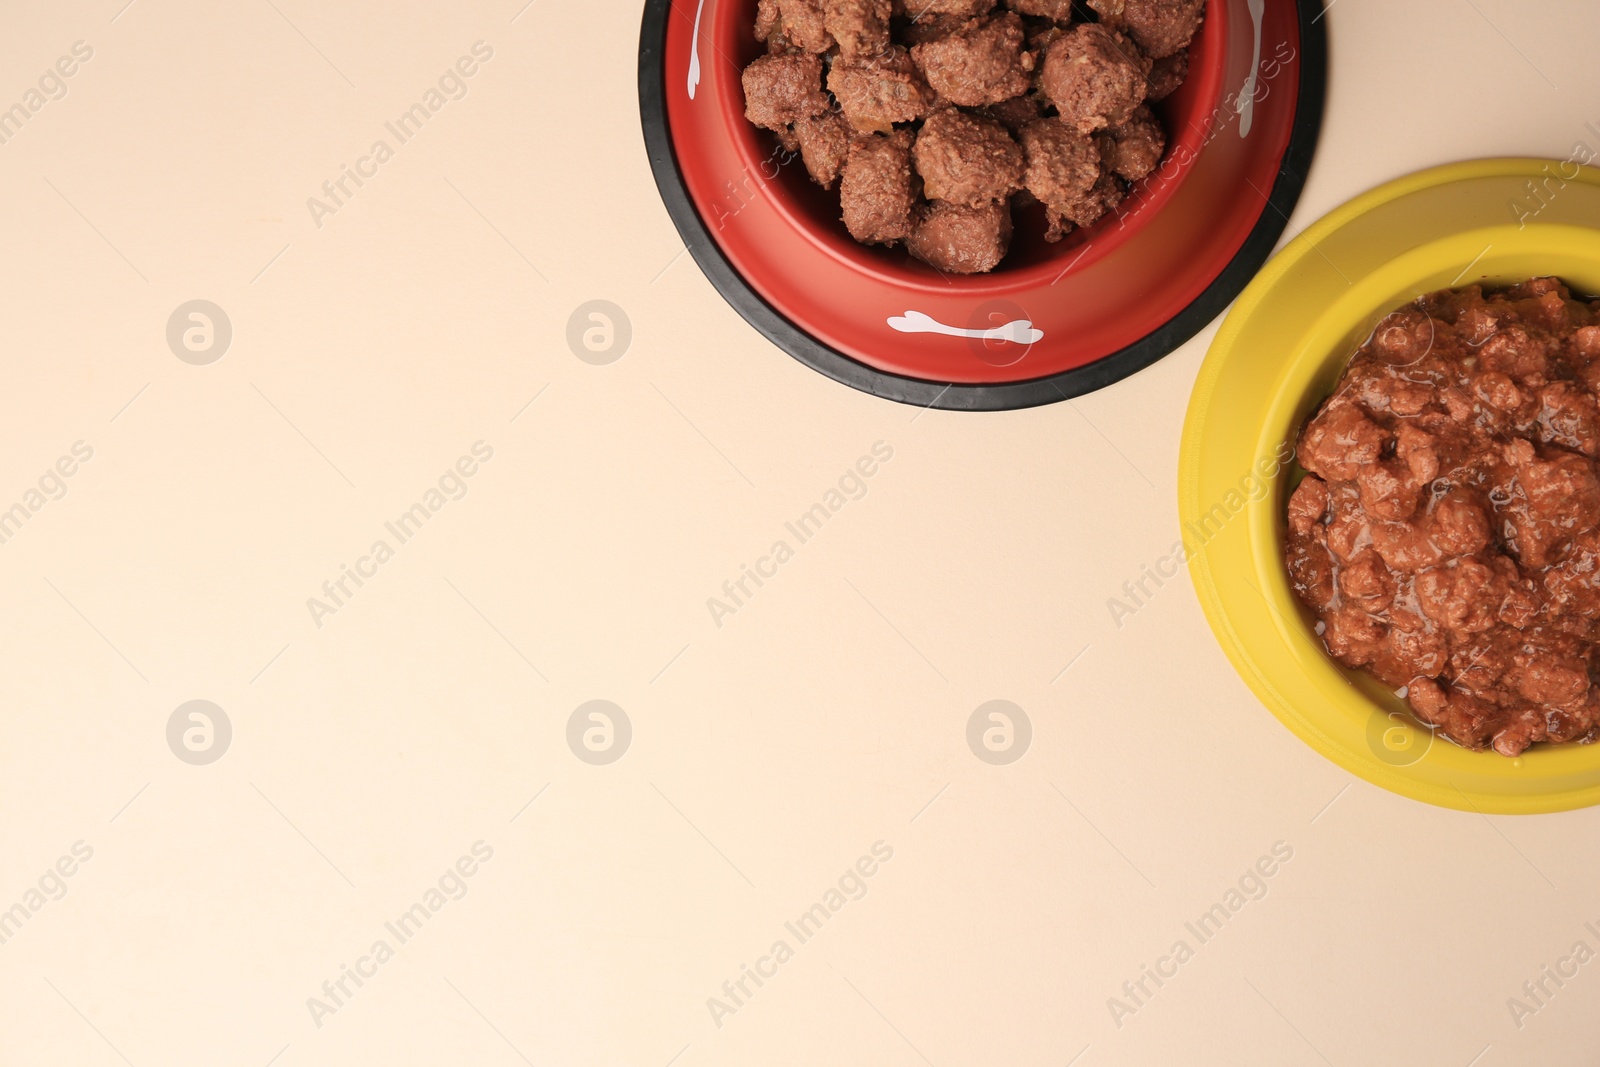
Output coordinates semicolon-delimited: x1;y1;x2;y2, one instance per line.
638;0;1326;411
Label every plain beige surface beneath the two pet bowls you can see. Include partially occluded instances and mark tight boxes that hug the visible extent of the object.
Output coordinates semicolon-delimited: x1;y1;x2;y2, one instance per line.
0;0;1600;1067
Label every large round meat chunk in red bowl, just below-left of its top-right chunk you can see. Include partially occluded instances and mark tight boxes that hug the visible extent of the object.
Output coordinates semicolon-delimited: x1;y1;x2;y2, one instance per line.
1040;22;1150;133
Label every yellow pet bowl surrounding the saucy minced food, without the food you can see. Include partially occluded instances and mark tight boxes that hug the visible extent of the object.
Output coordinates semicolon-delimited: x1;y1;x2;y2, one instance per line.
1178;160;1600;814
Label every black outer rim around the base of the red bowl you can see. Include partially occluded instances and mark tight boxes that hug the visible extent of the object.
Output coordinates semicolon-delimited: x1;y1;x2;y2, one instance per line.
638;0;1328;411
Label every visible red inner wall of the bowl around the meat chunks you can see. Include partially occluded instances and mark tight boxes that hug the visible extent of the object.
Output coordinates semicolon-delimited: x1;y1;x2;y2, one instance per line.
707;0;1229;285
